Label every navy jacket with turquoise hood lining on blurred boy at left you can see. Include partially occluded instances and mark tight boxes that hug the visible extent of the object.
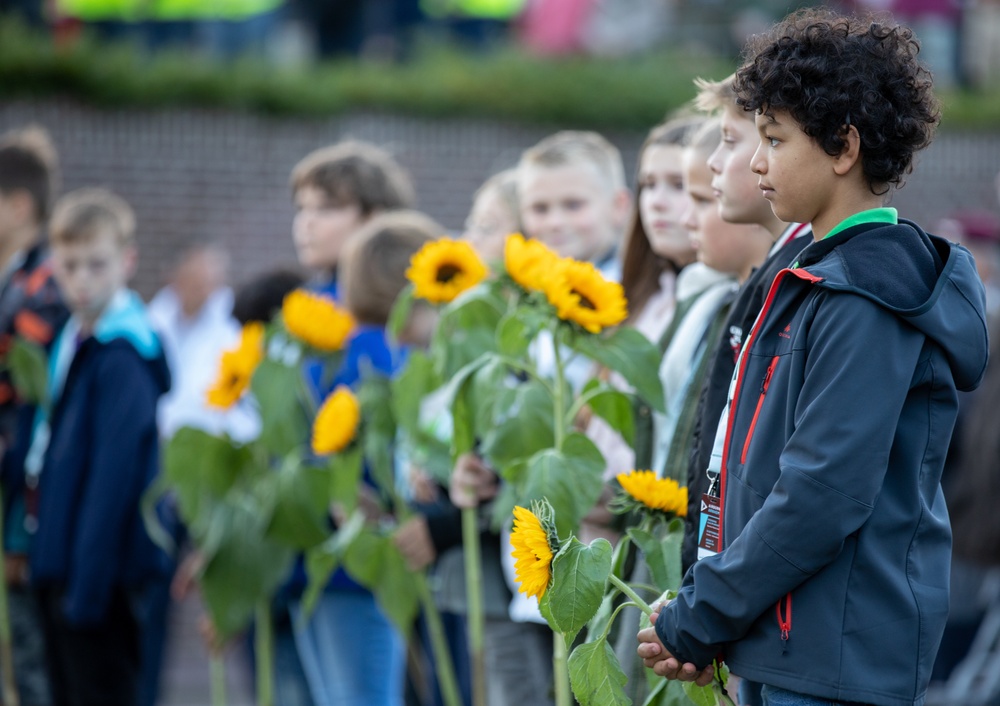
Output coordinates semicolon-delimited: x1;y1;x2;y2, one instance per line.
30;292;170;626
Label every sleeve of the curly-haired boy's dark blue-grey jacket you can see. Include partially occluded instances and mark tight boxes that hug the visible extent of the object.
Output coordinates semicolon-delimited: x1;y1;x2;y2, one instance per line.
656;292;923;666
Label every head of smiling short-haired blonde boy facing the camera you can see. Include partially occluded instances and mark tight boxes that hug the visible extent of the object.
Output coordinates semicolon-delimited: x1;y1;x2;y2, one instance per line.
517;130;631;272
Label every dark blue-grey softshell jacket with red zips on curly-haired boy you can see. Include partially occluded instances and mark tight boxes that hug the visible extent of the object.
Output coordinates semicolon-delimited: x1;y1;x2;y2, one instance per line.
656;221;988;706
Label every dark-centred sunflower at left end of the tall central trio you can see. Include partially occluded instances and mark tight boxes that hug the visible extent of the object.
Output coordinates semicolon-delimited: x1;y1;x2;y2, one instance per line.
406;238;489;304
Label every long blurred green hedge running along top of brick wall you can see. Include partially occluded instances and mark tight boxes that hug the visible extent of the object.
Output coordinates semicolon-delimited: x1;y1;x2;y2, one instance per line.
0;18;1000;130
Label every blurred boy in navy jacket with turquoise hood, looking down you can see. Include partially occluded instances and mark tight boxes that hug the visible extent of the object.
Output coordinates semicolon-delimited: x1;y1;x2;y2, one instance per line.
26;189;170;706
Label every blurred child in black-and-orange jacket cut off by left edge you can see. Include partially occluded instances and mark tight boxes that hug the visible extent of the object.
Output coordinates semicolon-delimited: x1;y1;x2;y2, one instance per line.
0;127;68;706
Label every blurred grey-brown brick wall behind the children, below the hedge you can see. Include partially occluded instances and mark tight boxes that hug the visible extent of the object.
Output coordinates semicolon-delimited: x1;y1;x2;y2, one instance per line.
0;99;1000;296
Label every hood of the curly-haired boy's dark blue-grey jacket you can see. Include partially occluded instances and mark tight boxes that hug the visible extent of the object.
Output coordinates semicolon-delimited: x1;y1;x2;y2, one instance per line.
799;219;989;390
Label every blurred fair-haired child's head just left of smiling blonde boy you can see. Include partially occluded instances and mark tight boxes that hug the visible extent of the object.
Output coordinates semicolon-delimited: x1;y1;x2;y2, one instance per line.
462;169;521;263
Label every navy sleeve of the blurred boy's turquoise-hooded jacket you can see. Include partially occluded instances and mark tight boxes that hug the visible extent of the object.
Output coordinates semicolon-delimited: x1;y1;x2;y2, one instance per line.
64;347;157;625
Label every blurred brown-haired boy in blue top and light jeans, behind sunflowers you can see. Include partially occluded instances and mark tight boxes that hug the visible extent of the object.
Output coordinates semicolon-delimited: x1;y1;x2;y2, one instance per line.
291;142;414;706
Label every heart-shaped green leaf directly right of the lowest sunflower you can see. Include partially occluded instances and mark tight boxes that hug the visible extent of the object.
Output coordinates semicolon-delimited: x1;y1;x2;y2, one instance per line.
546;537;612;637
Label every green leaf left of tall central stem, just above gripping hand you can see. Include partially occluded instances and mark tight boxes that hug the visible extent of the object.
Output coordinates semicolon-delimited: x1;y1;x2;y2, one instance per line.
481;380;555;468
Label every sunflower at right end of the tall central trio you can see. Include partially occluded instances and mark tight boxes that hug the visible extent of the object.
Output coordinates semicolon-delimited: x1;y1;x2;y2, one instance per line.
542;259;628;333
